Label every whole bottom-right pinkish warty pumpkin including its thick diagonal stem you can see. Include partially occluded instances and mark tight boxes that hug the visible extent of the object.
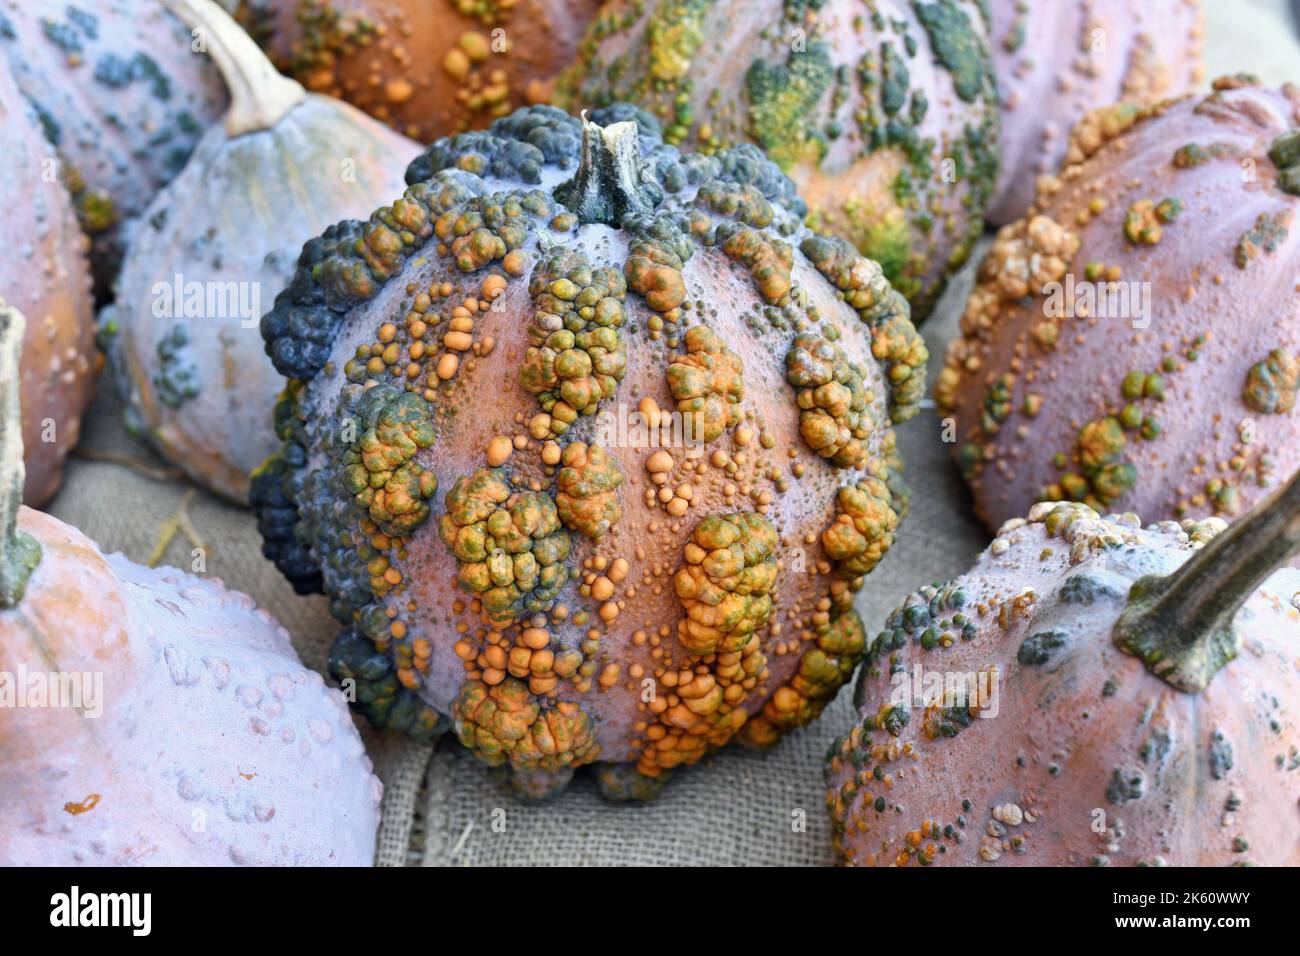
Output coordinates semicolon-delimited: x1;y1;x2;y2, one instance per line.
826;477;1300;866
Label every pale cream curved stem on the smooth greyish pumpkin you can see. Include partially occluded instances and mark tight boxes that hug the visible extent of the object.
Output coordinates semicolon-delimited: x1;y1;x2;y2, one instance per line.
164;0;307;137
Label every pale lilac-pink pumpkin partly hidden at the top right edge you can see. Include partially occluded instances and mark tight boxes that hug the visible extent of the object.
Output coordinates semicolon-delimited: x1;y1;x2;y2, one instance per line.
988;0;1204;226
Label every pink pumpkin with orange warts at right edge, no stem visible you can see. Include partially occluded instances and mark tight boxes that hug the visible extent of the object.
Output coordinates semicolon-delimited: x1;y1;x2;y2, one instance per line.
935;77;1300;528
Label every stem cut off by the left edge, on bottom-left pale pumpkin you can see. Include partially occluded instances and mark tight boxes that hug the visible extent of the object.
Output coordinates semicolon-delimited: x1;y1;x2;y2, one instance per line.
0;299;40;609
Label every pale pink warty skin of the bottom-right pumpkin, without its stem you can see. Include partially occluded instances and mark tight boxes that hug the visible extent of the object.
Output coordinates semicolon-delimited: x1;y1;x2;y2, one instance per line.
827;503;1300;866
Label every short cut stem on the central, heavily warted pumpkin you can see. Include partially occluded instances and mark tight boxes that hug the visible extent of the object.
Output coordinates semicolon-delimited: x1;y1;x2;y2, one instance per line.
554;112;654;226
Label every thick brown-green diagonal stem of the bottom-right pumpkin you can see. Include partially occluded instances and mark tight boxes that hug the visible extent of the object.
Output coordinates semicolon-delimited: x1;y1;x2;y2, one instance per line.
1114;475;1300;693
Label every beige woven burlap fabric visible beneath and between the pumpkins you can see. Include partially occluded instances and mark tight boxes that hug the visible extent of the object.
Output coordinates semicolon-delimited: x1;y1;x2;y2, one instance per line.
48;0;1300;866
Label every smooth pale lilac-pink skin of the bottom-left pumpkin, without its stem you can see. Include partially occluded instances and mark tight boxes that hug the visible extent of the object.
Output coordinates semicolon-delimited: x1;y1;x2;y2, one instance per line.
0;509;382;866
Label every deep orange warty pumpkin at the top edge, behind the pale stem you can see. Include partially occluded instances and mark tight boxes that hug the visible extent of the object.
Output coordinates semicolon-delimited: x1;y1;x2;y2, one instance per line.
235;0;599;143
